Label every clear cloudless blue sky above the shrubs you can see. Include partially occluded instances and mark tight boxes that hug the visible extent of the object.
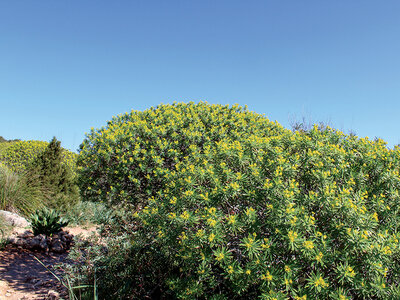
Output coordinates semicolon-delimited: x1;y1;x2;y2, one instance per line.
0;0;400;151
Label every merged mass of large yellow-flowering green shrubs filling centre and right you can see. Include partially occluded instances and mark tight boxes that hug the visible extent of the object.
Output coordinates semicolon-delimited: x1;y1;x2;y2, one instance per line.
78;103;400;299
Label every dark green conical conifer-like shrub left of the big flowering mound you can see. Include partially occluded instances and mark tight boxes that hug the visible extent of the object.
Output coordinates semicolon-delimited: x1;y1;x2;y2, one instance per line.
29;137;79;208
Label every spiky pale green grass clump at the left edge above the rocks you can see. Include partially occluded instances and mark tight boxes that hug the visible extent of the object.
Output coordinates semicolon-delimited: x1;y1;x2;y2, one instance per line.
0;162;47;216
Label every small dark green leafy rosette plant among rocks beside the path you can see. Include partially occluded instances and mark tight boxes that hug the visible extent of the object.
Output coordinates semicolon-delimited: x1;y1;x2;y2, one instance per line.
30;207;69;236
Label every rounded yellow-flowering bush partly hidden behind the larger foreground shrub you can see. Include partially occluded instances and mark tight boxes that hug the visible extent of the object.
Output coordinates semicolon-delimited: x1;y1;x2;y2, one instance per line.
77;102;283;204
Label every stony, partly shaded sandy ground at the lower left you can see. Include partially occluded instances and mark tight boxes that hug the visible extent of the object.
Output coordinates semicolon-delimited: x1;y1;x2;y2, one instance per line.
0;227;96;300
